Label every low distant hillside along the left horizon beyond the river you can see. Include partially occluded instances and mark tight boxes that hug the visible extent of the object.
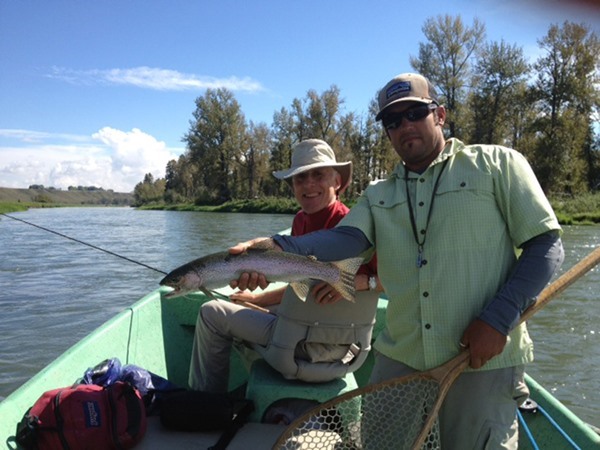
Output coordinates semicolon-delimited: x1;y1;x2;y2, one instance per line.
0;187;133;206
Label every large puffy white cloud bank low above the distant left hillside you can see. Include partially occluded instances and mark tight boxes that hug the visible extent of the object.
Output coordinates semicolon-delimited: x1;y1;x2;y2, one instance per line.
0;127;183;192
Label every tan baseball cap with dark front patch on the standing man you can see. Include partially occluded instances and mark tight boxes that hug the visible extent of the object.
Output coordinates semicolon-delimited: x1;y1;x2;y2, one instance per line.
375;73;440;120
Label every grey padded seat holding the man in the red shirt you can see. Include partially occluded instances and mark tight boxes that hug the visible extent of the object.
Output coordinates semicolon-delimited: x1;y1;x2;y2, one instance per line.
253;287;379;382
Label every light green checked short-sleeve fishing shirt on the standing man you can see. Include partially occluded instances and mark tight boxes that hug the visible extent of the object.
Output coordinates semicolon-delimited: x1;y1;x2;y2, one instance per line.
340;139;560;370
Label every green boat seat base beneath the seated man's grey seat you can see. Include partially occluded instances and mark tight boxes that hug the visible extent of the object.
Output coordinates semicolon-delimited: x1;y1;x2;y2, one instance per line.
246;359;358;422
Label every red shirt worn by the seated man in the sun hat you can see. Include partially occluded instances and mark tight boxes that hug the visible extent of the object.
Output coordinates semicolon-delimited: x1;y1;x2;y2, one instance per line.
292;200;377;276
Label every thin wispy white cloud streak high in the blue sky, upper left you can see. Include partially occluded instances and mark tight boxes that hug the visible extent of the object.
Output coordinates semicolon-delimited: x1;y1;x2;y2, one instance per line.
47;66;264;92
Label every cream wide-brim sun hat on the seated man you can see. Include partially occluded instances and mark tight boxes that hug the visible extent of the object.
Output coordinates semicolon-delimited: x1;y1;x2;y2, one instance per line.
273;139;352;193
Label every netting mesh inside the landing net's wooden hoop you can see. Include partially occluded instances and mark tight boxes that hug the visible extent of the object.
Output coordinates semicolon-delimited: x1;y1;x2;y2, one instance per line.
273;378;440;450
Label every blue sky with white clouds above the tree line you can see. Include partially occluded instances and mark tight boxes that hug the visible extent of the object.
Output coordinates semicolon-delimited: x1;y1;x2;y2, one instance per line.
0;0;600;192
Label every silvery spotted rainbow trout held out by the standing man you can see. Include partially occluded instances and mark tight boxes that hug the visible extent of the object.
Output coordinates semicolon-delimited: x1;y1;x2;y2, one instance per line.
160;249;363;301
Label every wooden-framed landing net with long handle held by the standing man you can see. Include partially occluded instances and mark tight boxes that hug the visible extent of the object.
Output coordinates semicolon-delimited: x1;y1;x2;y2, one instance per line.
273;247;600;450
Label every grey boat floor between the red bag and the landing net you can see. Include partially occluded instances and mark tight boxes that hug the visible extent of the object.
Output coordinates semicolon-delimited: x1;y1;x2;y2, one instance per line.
136;417;285;450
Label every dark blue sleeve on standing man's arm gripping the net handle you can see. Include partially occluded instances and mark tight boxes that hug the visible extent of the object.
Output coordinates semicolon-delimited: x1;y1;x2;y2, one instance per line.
478;230;565;335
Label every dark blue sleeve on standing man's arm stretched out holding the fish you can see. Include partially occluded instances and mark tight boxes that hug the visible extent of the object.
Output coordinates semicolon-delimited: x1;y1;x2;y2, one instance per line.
273;226;372;261
